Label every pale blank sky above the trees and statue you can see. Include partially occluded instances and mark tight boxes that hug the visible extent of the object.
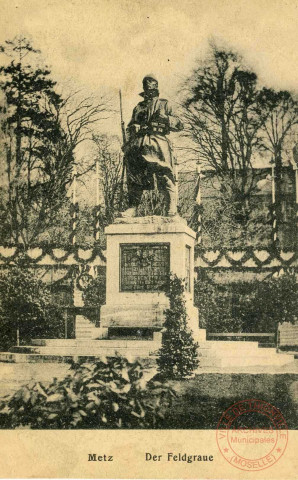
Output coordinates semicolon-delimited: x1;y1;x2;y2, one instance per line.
0;0;298;200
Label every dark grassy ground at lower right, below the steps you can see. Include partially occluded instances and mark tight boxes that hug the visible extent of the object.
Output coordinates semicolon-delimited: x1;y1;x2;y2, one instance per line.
164;373;298;429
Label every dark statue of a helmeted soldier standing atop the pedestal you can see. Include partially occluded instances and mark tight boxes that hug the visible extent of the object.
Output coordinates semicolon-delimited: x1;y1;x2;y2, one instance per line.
122;74;183;217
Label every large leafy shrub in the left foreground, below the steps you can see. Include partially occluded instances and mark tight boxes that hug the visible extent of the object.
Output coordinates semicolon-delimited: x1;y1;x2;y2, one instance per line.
0;356;175;429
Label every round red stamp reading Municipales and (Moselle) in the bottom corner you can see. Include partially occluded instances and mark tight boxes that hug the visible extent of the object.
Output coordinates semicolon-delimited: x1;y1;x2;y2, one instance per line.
216;399;288;471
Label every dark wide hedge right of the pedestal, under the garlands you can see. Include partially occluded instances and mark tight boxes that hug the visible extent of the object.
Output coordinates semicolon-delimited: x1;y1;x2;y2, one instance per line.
194;272;298;333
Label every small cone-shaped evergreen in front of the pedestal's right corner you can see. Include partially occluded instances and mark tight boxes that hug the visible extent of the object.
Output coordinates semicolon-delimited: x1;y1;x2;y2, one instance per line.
157;275;199;378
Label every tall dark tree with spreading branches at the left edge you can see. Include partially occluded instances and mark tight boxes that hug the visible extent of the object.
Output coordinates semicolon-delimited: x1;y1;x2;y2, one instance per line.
0;37;109;246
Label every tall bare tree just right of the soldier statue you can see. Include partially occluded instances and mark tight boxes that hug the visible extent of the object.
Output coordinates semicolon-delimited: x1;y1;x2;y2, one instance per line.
182;46;268;225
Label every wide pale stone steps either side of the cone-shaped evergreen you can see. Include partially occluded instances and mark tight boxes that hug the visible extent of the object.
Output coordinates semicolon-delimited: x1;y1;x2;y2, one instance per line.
6;338;294;368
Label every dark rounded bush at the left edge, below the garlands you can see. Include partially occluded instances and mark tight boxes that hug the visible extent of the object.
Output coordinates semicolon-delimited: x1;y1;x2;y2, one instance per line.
0;264;63;349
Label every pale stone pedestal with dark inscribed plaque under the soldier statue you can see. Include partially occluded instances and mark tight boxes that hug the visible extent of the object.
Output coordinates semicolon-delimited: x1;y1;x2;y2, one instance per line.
99;216;205;341
